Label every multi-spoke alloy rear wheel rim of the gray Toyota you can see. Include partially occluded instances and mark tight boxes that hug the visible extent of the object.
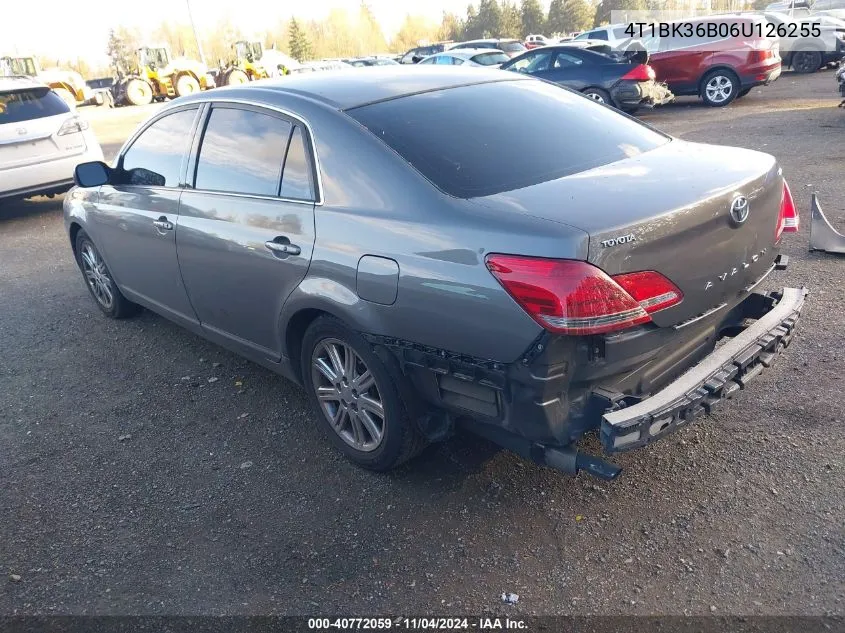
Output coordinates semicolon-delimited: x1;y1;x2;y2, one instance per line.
311;338;385;452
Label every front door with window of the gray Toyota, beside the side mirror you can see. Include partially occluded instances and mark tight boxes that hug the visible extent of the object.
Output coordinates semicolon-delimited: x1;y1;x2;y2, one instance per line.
91;104;199;323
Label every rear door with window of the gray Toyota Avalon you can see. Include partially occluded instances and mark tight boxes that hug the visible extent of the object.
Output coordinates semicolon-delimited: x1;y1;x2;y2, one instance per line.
176;103;319;360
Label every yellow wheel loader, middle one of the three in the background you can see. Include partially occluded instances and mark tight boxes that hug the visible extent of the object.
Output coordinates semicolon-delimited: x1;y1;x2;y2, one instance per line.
112;46;215;105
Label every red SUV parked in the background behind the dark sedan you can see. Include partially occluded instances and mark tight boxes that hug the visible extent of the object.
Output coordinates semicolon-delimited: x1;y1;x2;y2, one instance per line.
640;16;781;107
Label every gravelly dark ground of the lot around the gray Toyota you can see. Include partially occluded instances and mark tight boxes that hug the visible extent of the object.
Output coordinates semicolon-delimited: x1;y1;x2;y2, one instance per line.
0;71;845;615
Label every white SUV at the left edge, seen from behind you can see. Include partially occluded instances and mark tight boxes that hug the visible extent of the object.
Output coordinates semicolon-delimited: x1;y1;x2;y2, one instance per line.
0;77;103;200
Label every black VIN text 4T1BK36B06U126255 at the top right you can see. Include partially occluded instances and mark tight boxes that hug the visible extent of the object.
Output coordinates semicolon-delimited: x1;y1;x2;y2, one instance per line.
625;20;821;39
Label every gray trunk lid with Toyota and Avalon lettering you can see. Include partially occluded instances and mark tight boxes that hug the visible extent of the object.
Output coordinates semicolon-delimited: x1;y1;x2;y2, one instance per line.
484;140;783;326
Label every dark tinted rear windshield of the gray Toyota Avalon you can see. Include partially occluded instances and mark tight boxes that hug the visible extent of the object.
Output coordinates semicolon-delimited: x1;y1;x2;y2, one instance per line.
347;79;669;198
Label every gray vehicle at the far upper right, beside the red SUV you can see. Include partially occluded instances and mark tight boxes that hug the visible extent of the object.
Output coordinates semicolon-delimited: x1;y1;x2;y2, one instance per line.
765;13;845;73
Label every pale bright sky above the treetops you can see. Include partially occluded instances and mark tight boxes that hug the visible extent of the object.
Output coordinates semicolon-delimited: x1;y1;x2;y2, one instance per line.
0;0;549;62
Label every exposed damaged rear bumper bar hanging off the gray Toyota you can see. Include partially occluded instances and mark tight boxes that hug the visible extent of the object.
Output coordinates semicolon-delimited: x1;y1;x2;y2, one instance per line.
601;288;807;453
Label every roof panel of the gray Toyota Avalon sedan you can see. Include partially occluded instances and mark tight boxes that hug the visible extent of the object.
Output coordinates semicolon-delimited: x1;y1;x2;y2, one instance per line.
185;67;533;110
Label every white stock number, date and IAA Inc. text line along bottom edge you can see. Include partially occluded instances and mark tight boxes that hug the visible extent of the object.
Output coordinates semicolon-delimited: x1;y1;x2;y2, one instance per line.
308;617;528;631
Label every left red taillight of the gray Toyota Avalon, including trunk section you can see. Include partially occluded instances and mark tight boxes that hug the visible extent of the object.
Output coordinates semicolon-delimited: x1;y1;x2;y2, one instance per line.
487;255;681;335
